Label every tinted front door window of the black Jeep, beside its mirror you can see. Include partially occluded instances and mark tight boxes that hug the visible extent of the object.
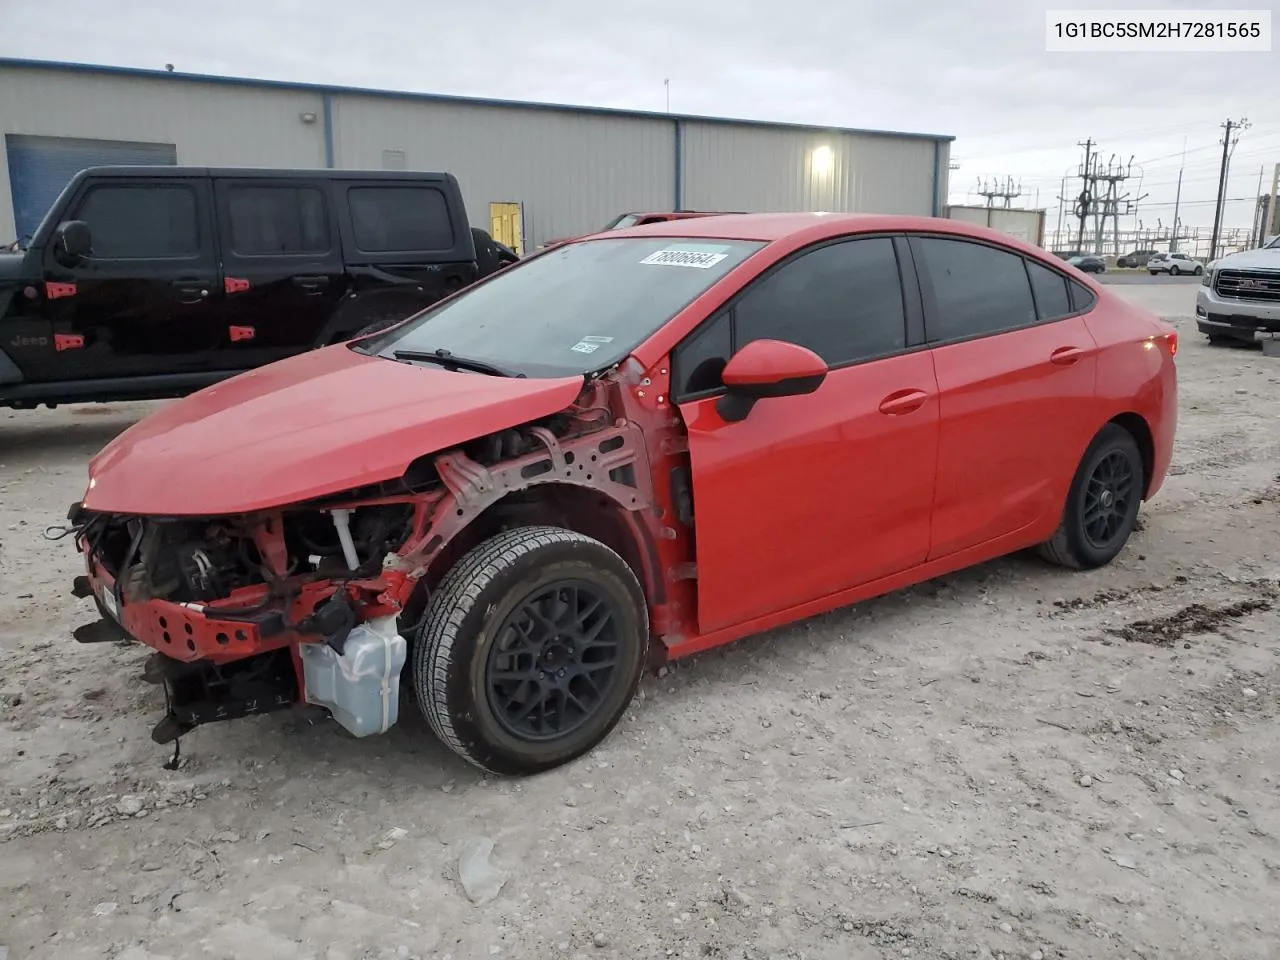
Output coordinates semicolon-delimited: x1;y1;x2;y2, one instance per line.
72;183;200;260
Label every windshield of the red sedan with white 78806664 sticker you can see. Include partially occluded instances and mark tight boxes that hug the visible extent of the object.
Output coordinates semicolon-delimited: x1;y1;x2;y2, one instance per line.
362;237;764;378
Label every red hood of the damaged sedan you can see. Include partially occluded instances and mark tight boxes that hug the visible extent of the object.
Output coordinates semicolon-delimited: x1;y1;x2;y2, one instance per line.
84;344;582;516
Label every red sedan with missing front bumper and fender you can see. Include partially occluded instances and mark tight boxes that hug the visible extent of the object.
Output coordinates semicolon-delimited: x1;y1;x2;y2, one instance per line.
70;214;1178;773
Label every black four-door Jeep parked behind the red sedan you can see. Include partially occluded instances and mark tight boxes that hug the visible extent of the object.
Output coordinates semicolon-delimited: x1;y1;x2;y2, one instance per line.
0;166;515;407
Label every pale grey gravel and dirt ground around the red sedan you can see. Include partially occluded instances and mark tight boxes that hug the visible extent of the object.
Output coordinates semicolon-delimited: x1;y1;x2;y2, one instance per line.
0;283;1280;960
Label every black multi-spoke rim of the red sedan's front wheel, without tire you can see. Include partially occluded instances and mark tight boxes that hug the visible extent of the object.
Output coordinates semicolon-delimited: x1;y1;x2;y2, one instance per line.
485;580;622;741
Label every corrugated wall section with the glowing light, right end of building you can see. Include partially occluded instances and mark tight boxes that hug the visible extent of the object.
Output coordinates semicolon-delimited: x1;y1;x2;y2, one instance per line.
681;120;946;216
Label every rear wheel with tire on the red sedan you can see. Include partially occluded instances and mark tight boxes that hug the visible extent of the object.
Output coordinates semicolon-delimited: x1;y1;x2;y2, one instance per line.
1037;424;1144;570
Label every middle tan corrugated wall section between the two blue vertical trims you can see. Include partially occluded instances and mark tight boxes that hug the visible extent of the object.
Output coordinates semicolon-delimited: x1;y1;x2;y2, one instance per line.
325;95;676;250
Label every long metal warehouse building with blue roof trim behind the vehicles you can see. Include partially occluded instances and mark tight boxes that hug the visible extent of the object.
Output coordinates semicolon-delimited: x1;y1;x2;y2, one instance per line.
0;59;952;252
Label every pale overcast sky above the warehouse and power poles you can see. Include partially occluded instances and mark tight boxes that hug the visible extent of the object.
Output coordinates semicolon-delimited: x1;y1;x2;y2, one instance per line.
0;0;1280;240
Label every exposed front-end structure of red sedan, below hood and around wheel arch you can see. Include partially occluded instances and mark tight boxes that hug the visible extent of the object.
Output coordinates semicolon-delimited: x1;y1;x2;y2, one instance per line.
68;383;660;742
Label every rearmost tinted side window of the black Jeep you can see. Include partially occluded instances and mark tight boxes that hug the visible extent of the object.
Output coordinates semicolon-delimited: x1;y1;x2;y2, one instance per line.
347;184;456;253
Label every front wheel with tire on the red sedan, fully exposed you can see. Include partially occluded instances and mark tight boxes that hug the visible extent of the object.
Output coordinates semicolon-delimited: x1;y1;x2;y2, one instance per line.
412;526;649;776
